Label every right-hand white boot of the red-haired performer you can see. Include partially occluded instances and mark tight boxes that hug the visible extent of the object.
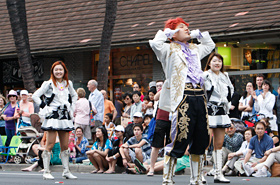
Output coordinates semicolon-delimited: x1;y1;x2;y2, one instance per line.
190;154;204;185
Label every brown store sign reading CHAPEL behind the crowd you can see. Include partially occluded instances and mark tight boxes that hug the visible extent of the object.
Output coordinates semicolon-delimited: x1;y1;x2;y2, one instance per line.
113;49;153;75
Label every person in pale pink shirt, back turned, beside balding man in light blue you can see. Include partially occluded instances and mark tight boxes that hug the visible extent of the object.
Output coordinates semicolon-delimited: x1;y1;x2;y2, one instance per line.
74;88;92;139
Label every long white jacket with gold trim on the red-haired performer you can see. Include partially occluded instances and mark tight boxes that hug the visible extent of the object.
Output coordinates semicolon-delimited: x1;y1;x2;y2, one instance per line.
149;30;215;112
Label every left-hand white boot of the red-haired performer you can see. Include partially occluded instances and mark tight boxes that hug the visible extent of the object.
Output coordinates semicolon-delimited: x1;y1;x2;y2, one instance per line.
162;155;176;185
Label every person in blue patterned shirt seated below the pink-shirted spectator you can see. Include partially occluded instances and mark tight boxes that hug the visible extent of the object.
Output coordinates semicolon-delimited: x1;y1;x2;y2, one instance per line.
72;127;89;163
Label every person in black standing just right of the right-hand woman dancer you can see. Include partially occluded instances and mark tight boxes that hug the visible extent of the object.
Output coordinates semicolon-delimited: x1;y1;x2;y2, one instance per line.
229;76;240;119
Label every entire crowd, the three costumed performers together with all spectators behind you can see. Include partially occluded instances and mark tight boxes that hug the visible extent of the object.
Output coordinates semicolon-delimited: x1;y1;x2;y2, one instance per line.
0;18;280;184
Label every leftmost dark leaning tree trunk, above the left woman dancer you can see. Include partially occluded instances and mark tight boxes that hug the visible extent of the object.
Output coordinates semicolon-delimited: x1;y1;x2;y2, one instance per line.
6;0;36;93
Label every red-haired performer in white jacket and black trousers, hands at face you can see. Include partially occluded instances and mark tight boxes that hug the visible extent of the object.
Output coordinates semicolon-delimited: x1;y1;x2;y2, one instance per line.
149;17;215;184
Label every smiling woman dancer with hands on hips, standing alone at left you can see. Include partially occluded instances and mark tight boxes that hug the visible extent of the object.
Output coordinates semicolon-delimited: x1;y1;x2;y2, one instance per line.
33;61;78;179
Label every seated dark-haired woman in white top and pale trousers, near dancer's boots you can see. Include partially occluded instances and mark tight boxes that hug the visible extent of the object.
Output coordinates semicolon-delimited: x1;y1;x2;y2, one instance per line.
223;127;256;176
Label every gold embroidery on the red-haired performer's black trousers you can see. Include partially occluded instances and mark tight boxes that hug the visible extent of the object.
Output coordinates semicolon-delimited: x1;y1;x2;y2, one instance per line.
177;102;191;142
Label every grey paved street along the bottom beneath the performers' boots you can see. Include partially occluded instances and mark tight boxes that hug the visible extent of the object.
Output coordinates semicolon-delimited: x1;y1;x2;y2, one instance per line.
0;171;280;185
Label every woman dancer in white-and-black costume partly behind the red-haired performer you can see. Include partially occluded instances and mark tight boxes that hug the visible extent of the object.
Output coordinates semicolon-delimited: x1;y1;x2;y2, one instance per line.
203;53;234;183
